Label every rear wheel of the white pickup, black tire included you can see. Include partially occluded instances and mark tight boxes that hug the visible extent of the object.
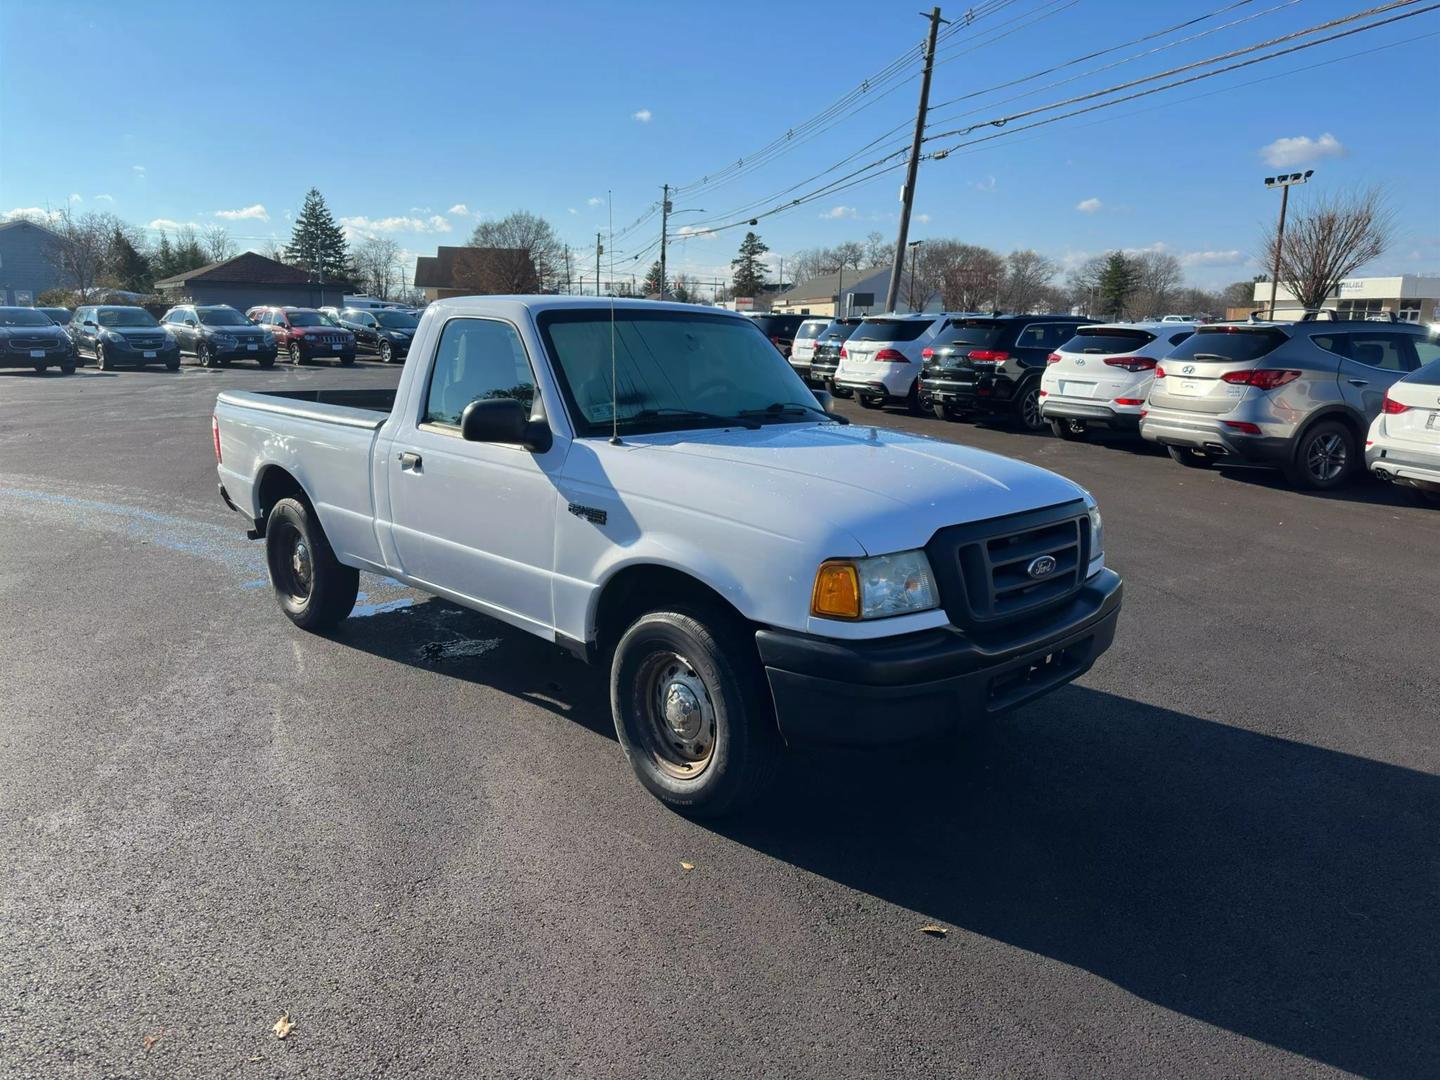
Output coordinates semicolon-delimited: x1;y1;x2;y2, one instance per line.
265;498;360;631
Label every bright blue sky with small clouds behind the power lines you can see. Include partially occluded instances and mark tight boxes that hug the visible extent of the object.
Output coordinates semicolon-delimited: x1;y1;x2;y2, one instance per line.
0;0;1440;292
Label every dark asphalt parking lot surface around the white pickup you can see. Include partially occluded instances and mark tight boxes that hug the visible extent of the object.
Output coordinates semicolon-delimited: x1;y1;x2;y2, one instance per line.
0;361;1440;1077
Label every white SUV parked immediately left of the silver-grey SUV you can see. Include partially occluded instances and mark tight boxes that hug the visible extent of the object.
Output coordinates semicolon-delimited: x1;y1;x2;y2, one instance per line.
1040;317;1197;439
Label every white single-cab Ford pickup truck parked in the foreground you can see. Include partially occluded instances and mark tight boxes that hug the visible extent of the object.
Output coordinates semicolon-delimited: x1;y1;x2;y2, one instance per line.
213;297;1120;815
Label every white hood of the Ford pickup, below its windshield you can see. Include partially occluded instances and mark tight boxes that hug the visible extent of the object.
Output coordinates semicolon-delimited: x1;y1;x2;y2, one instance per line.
590;423;1086;554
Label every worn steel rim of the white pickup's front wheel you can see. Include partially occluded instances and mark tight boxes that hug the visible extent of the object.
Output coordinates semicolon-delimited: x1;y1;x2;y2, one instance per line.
636;649;716;780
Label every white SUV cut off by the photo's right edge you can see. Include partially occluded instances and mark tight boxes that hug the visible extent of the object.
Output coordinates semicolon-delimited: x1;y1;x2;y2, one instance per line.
1365;351;1440;507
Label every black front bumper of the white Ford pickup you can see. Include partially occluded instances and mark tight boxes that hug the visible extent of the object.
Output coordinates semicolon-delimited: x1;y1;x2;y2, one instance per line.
755;569;1123;746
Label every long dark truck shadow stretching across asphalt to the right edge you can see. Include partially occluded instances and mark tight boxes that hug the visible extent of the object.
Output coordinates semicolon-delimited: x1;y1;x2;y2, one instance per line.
717;687;1440;1077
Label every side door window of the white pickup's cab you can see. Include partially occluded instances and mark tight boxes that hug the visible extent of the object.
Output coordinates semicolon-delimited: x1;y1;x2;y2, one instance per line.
423;318;536;426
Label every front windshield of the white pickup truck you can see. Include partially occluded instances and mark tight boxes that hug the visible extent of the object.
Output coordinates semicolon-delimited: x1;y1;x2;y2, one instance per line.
539;308;819;435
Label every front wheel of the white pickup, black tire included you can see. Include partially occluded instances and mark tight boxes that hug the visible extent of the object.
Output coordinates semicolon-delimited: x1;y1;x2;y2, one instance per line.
611;606;780;818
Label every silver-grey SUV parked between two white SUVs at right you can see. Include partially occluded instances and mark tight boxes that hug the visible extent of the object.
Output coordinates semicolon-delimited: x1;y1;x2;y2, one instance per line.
1140;320;1428;490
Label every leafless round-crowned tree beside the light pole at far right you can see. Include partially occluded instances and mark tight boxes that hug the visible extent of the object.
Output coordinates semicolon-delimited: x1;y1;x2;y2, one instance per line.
1264;187;1394;308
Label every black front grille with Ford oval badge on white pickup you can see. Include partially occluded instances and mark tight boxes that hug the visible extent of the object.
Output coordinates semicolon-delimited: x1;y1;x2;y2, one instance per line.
926;501;1090;631
